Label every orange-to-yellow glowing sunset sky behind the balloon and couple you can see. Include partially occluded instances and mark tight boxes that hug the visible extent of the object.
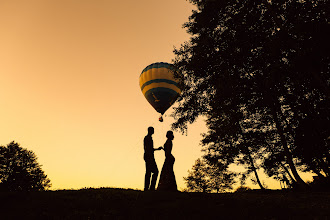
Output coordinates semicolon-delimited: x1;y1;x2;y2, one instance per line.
0;0;310;189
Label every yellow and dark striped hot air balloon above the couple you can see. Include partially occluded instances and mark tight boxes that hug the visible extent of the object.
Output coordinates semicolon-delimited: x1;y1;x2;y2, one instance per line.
140;62;181;122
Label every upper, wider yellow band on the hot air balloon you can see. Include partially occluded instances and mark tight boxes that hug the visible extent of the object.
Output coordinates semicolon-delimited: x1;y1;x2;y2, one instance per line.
140;67;179;87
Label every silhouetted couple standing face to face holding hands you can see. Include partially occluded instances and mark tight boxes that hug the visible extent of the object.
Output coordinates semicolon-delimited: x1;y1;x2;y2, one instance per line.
144;127;177;191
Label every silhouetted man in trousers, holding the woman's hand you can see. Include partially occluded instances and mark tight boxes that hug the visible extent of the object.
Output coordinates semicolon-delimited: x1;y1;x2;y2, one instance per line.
143;127;162;191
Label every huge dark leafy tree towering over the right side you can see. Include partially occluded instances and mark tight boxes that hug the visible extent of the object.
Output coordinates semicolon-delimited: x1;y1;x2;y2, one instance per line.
173;0;330;189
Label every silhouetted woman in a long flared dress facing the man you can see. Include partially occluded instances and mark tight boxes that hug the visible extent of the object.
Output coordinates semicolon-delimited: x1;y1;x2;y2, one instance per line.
157;131;177;191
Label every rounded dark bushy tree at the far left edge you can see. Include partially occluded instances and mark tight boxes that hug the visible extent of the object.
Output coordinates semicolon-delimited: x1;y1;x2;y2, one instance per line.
0;141;51;191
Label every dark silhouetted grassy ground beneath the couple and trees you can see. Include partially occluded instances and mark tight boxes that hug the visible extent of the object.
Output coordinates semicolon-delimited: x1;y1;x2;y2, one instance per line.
0;188;330;219
